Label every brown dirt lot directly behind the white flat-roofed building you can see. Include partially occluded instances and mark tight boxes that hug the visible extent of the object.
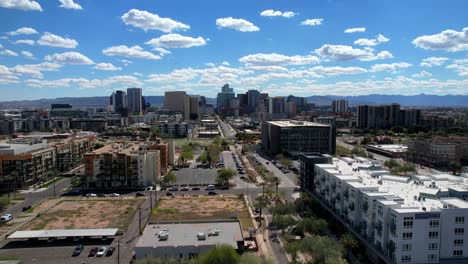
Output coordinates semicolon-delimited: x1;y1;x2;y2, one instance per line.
151;195;253;234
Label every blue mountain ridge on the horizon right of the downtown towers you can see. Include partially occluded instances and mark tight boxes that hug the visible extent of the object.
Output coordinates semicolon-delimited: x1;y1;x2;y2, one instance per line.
307;94;468;106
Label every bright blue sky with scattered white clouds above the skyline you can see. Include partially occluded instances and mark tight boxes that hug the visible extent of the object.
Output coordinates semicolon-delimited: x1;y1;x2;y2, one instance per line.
0;0;468;101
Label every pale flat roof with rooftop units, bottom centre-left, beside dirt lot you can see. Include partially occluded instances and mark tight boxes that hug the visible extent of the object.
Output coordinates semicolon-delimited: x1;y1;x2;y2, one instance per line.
135;221;244;248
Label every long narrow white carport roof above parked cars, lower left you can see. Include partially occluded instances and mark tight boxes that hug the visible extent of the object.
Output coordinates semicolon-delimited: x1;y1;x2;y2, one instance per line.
8;228;118;239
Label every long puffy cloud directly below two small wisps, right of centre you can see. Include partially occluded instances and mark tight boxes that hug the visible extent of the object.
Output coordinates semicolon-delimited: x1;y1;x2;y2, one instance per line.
314;44;393;61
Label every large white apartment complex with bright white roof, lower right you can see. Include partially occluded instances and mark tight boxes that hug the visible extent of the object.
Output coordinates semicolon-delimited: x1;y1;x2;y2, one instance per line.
309;158;468;264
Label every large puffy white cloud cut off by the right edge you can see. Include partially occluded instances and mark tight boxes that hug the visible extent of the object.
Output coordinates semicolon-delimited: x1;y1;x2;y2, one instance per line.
412;27;468;52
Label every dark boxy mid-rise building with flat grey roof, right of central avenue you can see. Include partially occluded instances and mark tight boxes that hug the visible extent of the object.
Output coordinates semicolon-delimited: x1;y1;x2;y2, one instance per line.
262;120;336;156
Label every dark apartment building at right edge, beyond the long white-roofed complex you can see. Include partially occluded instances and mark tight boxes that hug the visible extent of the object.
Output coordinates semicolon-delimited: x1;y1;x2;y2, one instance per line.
406;137;468;167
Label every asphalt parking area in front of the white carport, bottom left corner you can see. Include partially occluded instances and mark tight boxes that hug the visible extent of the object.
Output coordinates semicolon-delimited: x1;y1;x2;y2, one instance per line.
0;239;118;264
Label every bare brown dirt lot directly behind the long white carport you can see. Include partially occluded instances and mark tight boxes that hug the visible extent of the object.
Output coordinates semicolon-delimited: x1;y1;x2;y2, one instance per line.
24;198;143;230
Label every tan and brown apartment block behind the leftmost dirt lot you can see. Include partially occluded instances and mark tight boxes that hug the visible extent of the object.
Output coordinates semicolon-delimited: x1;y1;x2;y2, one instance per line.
84;142;161;189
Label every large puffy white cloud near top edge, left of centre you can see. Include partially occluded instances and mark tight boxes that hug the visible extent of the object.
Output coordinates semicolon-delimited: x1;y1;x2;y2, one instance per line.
121;9;190;33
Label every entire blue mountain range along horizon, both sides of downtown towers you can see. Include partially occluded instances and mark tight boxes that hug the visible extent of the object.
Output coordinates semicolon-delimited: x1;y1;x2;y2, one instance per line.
0;94;468;108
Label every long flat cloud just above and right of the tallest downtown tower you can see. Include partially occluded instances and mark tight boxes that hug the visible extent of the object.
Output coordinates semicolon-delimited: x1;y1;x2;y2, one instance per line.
239;53;320;67
